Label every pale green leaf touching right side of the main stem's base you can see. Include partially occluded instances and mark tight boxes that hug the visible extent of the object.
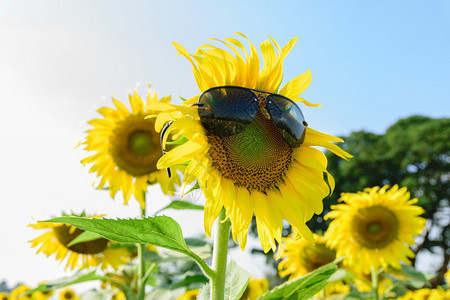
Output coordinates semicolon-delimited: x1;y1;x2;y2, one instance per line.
224;261;250;300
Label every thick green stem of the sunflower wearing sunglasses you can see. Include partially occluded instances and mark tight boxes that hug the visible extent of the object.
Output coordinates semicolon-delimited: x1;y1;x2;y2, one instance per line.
210;209;231;300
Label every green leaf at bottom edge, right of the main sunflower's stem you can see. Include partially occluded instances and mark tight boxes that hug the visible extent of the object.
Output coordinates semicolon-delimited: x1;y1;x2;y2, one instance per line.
258;261;338;300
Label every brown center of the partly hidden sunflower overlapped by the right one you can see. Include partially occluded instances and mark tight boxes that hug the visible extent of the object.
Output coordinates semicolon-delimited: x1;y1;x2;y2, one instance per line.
300;243;336;272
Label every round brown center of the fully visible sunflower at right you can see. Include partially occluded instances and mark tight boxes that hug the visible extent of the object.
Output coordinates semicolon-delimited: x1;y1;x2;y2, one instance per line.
351;205;398;249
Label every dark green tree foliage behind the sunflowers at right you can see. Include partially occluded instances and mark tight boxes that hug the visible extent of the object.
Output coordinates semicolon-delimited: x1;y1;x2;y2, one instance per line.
308;116;450;280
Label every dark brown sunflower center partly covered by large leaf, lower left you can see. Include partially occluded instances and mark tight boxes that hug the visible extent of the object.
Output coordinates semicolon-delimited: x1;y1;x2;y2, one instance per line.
53;225;108;254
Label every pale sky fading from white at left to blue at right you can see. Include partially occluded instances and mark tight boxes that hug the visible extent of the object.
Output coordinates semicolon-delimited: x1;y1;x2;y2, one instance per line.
0;0;450;284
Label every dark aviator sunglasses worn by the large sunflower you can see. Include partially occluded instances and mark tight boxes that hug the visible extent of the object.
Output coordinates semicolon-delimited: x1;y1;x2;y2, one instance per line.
193;86;308;148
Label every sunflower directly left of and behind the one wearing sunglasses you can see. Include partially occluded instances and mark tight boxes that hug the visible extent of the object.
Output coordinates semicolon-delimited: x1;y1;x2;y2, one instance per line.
81;86;179;208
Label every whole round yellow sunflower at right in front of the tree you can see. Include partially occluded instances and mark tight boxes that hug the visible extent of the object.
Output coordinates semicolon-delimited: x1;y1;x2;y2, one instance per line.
325;185;426;274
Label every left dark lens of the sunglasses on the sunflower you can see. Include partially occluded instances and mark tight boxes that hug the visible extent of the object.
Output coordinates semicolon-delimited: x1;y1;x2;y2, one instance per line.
198;87;258;137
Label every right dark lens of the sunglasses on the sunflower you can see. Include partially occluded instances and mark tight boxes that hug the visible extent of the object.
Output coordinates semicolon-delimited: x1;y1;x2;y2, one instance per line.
266;95;306;148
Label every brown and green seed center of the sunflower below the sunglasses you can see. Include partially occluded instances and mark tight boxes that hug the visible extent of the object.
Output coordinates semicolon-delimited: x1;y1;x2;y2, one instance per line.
208;101;293;192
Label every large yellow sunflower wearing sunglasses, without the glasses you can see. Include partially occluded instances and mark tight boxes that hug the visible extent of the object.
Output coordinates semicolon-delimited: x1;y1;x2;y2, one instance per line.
156;34;350;252
